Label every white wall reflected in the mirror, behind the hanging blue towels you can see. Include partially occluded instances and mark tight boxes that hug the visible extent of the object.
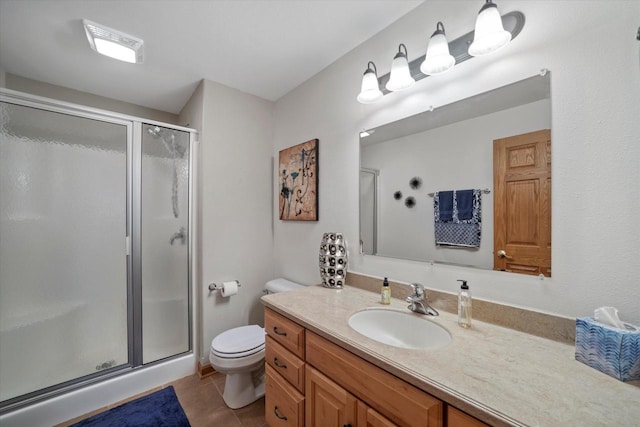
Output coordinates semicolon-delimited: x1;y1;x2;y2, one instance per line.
360;99;551;269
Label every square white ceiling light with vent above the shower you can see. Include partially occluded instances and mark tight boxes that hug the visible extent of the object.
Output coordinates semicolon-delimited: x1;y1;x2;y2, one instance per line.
82;19;144;64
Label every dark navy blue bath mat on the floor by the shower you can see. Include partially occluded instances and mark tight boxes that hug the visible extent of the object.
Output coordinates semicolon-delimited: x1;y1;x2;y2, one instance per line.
71;386;190;427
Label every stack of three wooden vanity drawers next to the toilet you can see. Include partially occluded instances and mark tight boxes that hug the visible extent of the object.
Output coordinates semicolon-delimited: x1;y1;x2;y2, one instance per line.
264;309;305;427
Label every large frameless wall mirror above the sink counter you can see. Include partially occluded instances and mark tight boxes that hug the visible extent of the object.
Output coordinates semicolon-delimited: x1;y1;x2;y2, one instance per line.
360;73;551;276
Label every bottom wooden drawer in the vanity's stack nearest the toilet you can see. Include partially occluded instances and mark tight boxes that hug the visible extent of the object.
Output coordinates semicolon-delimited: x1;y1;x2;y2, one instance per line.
264;365;304;427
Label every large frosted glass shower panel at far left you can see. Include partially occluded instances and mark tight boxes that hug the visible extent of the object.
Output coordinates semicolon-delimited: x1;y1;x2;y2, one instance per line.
0;102;131;401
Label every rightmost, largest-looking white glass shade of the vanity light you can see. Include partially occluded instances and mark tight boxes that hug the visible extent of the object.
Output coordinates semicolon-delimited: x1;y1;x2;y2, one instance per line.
469;0;511;56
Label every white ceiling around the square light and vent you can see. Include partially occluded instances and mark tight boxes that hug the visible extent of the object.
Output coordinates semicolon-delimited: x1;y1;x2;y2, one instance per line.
0;0;423;114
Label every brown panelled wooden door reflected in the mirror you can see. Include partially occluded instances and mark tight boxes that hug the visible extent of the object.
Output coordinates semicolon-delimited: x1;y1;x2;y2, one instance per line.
493;129;551;276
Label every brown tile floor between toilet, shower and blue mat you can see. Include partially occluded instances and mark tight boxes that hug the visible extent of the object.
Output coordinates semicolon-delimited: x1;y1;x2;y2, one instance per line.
55;373;266;427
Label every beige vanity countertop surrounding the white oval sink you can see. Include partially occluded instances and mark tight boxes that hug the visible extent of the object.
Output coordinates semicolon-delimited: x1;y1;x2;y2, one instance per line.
262;286;640;427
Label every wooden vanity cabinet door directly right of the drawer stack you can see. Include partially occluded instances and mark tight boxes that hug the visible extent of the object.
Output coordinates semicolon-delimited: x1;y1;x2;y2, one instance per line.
305;365;357;427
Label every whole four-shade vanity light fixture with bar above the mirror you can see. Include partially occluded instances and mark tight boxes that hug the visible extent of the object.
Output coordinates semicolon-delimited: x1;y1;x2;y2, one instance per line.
358;0;525;104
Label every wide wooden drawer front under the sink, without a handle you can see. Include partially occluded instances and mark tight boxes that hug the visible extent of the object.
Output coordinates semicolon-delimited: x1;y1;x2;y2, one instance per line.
306;331;444;427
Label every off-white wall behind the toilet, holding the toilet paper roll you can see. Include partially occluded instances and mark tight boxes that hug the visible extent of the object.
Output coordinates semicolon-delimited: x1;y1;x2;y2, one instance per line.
180;80;274;363
